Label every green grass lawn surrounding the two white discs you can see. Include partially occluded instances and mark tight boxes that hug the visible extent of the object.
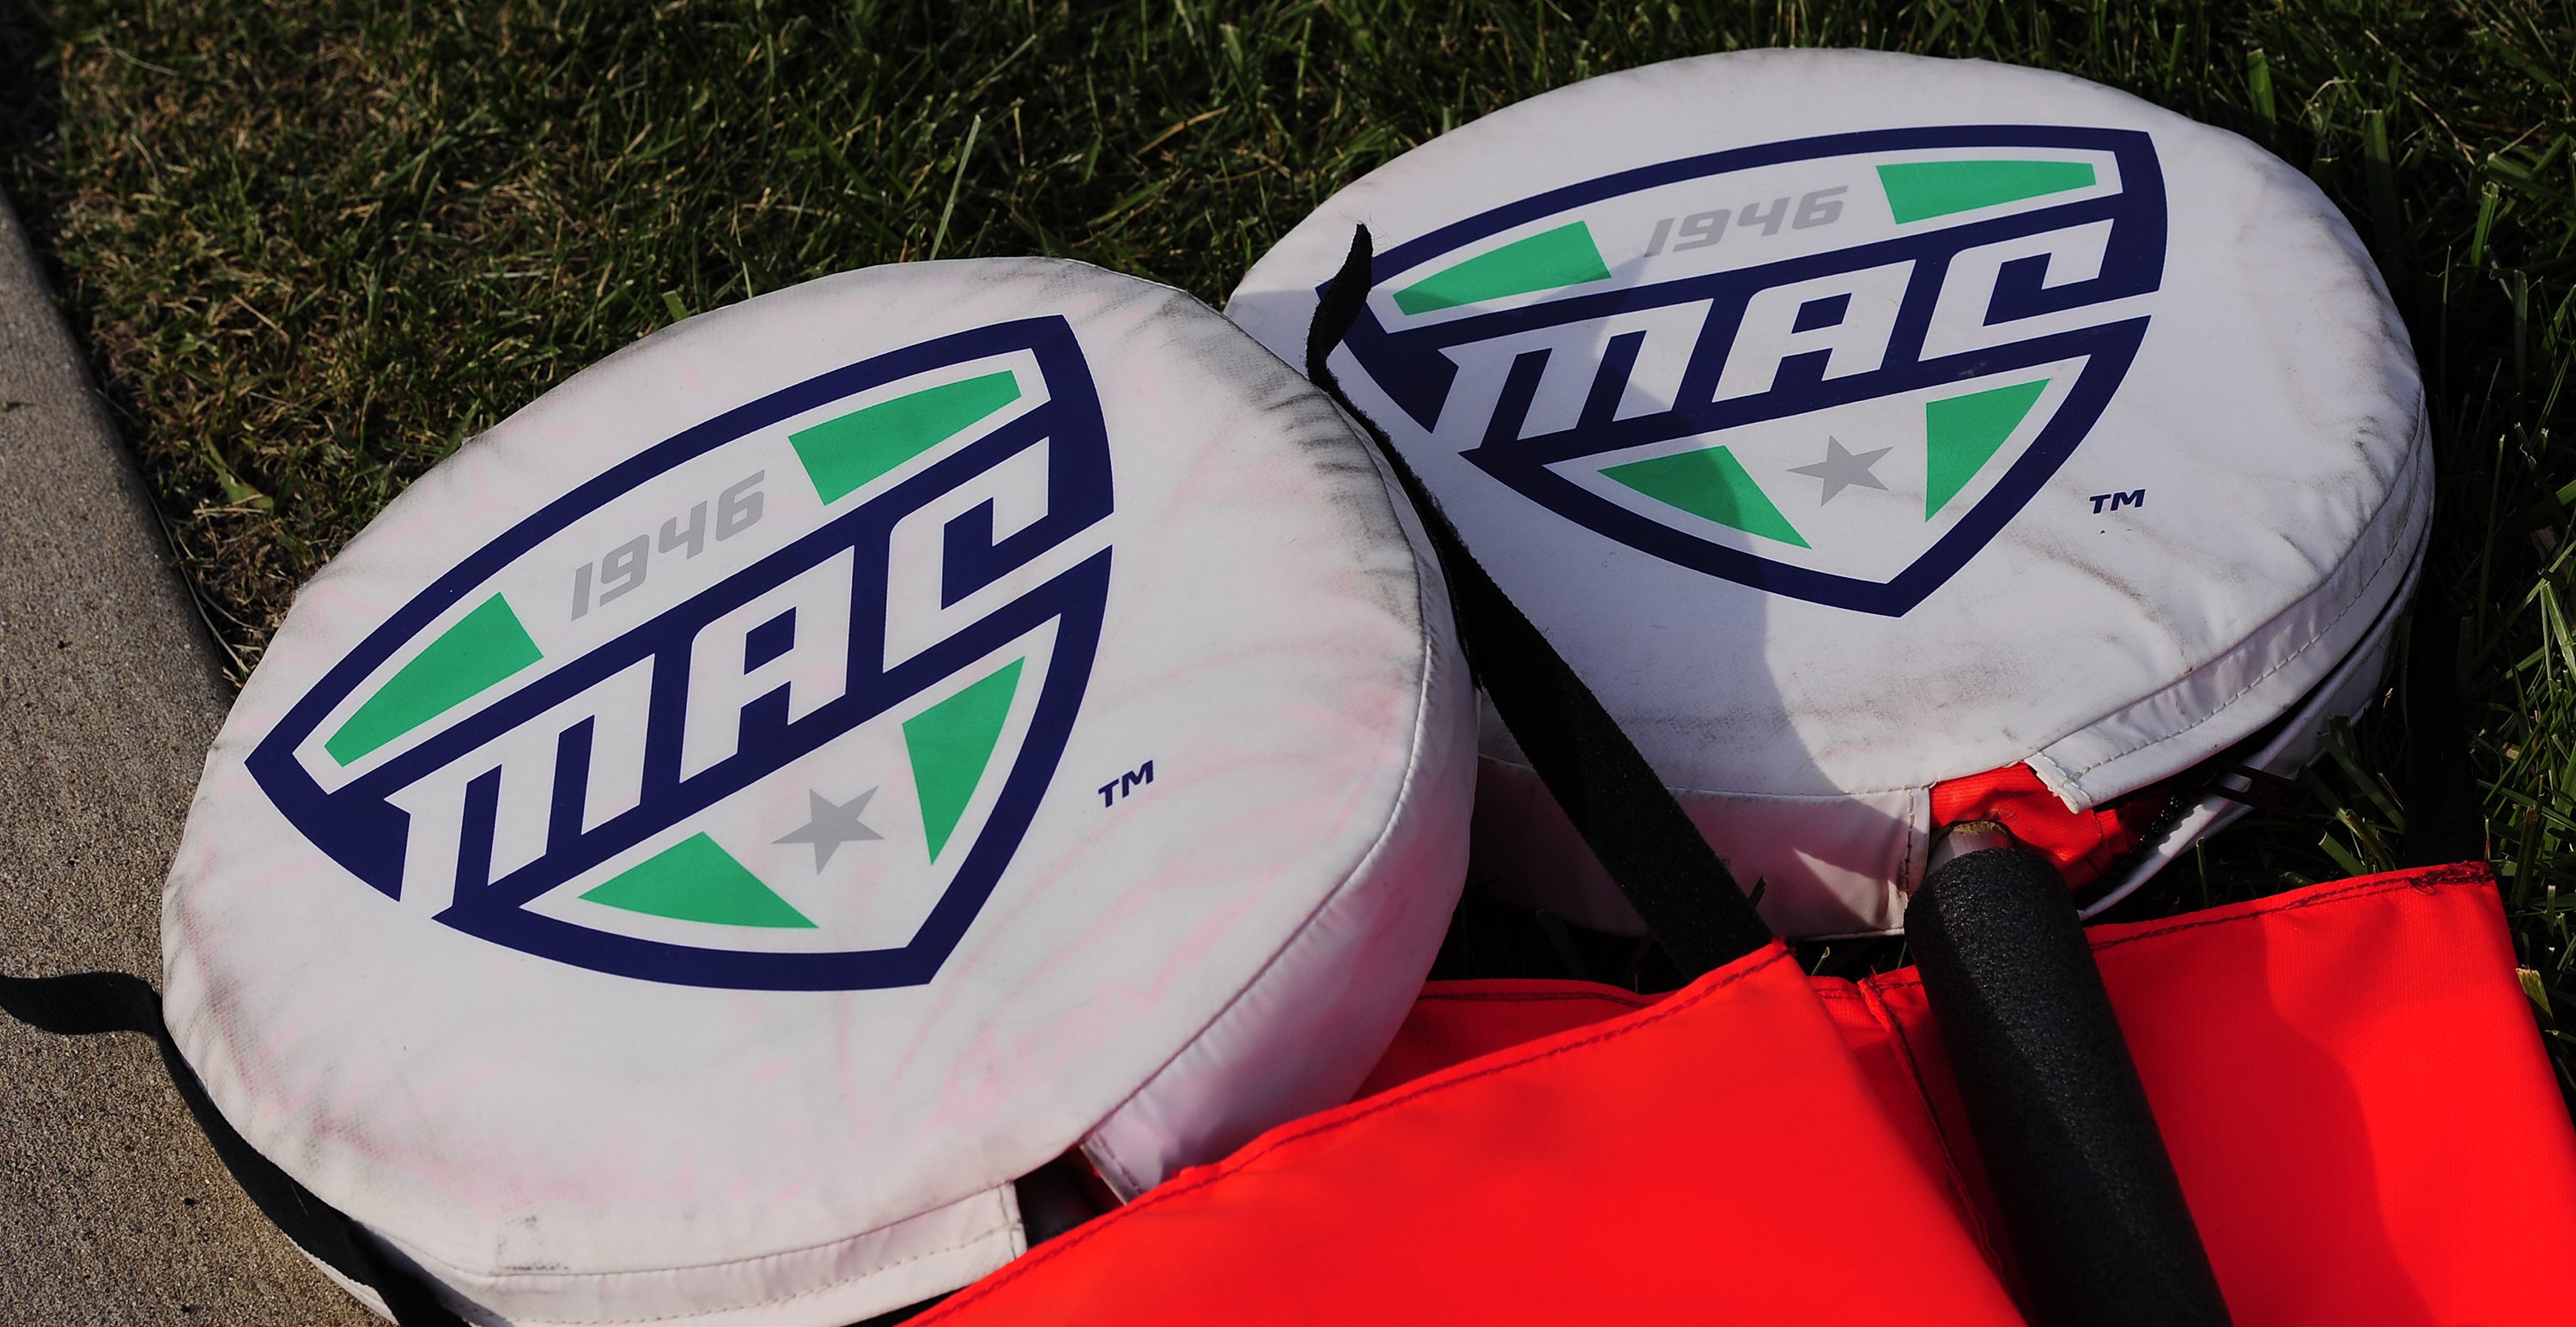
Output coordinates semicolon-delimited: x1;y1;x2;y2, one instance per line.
0;0;2576;1087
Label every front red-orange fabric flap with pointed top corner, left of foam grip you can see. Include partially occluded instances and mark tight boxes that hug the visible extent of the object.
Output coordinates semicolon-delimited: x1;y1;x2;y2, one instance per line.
912;946;2020;1327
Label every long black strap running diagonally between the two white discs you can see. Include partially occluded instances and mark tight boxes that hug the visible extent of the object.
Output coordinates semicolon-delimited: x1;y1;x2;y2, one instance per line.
1306;227;1770;977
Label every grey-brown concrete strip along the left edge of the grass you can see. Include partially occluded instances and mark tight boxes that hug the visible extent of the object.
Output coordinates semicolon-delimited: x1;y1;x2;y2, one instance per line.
0;198;374;1327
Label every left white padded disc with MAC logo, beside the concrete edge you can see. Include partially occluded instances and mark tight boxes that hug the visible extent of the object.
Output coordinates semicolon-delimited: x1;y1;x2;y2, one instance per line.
165;260;1473;1327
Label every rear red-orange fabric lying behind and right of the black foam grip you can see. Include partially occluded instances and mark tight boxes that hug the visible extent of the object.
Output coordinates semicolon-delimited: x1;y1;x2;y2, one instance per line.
1350;866;2576;1327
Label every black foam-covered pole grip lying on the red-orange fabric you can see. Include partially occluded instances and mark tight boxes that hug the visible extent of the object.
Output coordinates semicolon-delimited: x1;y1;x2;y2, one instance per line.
1906;848;2228;1327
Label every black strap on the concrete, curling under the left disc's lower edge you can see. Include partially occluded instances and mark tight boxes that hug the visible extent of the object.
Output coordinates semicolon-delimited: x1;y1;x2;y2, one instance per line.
0;971;464;1327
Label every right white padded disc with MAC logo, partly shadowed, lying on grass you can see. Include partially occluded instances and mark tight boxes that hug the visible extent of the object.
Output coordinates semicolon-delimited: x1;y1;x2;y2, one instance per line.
1226;52;2432;935
